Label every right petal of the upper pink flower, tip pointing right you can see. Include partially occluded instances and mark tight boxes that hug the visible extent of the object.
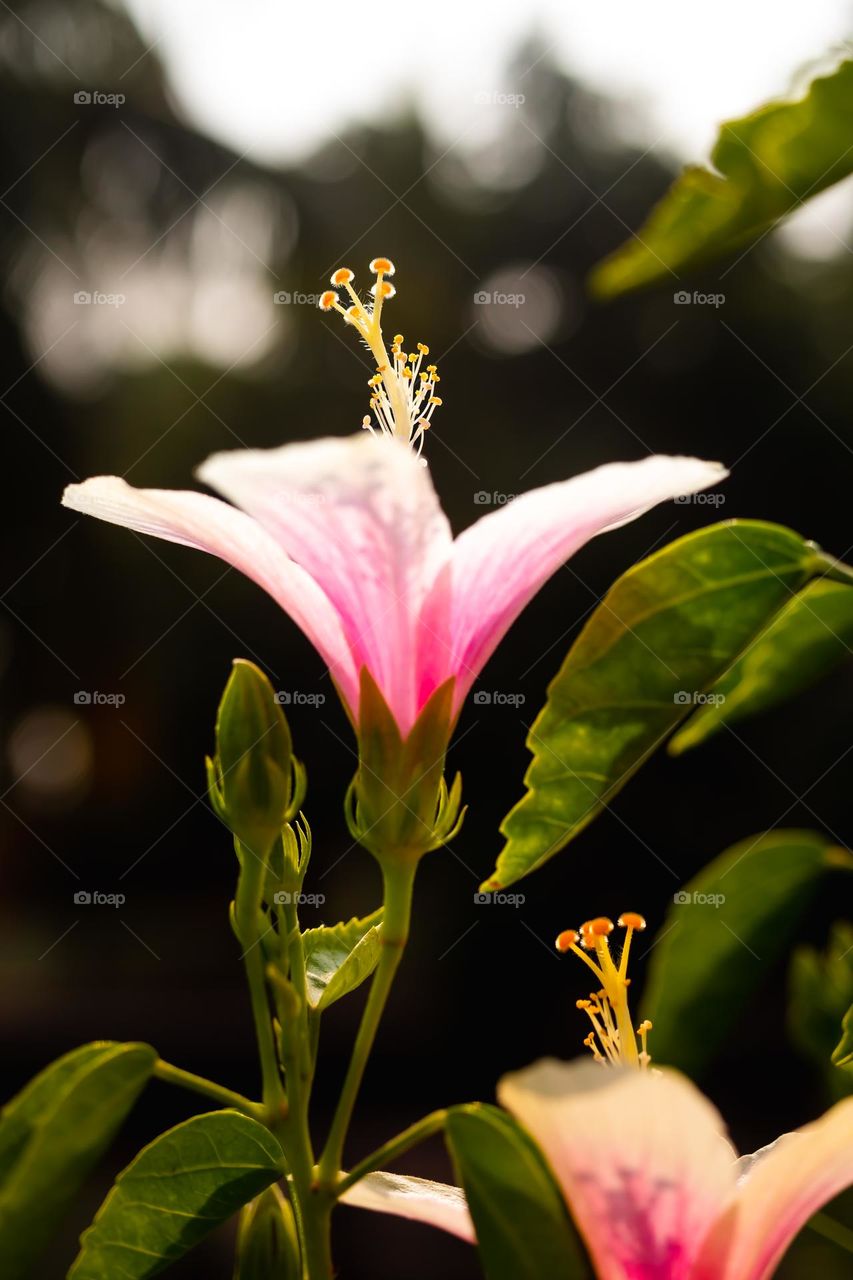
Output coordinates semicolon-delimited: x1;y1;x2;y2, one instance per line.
425;456;727;701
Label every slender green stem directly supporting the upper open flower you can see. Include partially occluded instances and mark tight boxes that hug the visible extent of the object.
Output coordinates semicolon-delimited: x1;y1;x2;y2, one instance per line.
318;861;416;1190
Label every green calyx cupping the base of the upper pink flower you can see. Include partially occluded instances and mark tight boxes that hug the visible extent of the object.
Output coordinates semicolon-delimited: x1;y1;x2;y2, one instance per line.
346;667;462;864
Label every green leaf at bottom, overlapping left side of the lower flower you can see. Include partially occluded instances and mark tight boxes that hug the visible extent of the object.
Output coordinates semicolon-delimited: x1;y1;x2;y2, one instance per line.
444;1103;593;1280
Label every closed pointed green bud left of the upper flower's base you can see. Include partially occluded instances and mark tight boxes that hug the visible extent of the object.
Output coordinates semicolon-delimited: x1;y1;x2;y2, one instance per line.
206;658;295;856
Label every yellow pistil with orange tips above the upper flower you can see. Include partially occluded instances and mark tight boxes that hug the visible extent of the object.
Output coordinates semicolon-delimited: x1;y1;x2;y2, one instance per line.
319;257;442;454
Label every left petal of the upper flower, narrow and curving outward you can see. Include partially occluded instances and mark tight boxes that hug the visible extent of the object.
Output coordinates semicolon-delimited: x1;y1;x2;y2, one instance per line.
63;476;359;709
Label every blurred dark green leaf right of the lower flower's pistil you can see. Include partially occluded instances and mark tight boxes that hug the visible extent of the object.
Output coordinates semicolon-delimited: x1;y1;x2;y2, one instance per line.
643;831;853;1075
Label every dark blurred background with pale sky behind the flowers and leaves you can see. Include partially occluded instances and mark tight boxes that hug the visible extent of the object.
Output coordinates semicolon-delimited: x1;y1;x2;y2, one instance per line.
0;0;853;1280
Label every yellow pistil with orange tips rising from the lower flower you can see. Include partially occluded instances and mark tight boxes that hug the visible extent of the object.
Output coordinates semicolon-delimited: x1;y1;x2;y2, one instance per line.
556;911;652;1070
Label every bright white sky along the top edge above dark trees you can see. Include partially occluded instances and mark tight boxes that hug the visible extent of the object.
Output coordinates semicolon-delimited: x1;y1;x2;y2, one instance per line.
124;0;853;161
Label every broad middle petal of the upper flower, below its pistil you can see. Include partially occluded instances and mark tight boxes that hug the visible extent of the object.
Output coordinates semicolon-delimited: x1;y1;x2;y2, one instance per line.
197;431;452;731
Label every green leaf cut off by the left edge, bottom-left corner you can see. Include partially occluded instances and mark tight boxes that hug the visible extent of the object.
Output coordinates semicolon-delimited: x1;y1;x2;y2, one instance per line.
0;1042;158;1280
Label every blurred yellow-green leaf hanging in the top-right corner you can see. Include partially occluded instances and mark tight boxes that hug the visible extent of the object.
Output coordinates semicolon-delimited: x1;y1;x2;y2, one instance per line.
589;61;853;298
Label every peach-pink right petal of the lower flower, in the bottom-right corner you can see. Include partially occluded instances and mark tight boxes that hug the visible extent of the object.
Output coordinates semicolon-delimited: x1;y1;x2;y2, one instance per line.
695;1098;853;1280
